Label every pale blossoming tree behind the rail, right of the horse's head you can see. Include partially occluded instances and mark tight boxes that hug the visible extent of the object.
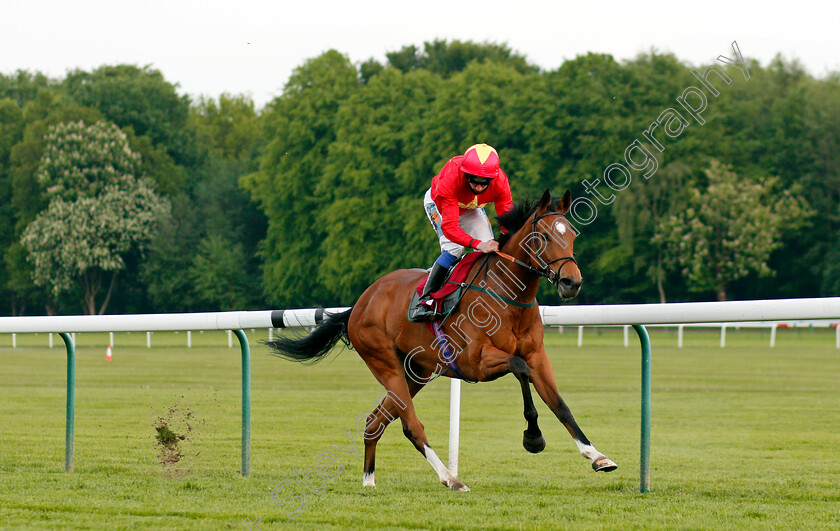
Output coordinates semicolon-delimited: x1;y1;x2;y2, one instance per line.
654;161;810;301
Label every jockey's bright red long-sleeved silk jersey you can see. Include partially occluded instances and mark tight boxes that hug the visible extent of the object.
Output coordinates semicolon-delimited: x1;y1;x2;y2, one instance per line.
432;156;513;248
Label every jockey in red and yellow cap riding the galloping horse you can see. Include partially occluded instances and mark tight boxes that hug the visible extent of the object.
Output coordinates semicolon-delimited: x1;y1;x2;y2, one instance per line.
411;144;513;321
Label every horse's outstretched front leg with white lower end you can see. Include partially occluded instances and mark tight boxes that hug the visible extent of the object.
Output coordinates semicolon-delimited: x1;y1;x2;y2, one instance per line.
526;347;618;472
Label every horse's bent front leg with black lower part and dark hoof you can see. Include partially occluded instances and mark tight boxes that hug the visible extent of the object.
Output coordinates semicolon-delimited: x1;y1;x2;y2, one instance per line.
479;344;545;454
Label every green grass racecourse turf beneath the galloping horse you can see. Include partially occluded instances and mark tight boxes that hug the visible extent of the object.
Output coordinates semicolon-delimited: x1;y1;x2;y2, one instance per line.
0;329;840;530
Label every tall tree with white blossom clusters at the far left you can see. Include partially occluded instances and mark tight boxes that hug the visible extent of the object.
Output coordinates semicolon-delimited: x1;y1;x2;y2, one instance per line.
21;122;169;314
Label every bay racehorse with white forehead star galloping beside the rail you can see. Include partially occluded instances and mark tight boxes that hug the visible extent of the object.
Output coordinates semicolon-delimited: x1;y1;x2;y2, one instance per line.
267;190;616;491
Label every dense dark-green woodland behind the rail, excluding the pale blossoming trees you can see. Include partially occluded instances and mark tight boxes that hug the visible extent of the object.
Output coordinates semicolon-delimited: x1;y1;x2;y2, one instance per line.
0;41;840;314
